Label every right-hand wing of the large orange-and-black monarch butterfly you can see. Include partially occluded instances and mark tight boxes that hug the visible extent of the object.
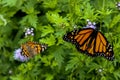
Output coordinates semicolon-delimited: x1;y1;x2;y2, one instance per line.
95;32;114;60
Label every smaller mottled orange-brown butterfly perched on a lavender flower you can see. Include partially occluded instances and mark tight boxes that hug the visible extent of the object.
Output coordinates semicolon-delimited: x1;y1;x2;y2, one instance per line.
21;41;47;57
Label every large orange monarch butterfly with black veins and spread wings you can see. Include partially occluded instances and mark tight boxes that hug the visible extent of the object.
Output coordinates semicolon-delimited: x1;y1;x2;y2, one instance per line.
63;23;114;60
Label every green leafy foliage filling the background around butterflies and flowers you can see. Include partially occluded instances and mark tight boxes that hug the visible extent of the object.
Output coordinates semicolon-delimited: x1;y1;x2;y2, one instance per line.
0;0;120;80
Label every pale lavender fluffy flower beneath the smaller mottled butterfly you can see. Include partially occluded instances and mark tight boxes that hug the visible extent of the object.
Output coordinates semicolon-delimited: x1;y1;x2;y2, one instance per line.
14;48;29;62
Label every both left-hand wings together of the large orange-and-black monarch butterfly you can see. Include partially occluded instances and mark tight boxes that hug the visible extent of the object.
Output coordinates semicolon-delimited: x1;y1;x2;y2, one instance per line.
63;28;95;56
